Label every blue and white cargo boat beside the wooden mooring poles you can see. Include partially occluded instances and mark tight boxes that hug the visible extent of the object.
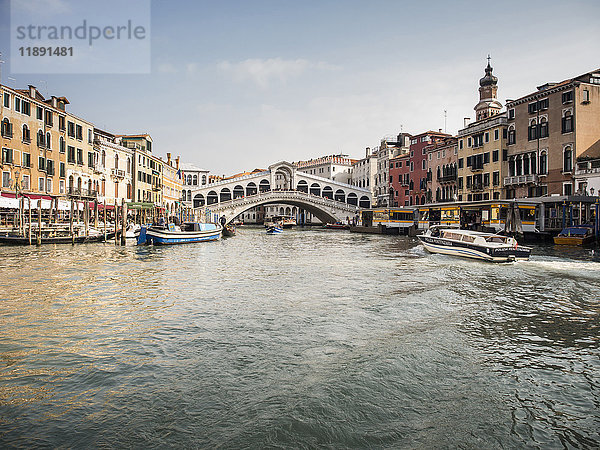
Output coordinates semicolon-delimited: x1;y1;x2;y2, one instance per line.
137;222;223;245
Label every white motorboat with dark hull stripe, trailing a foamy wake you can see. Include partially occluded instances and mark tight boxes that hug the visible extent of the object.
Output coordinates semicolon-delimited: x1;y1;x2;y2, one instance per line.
417;227;531;262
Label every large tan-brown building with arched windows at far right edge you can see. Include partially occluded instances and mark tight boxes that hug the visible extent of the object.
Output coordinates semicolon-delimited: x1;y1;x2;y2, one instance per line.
504;69;600;198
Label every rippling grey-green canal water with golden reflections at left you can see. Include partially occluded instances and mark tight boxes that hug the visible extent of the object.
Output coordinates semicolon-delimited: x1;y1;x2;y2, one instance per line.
0;227;600;448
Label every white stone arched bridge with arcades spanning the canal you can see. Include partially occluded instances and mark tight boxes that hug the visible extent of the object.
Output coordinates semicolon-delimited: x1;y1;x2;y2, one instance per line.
188;161;371;222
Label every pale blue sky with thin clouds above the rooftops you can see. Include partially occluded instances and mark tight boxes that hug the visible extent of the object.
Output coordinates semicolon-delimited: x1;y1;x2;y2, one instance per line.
0;0;600;175
